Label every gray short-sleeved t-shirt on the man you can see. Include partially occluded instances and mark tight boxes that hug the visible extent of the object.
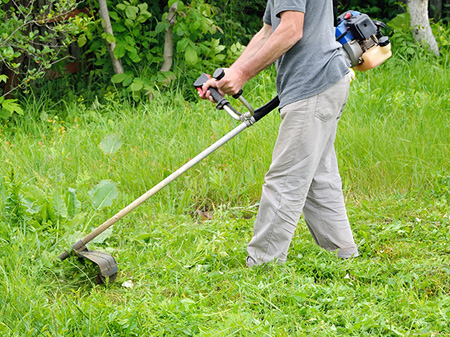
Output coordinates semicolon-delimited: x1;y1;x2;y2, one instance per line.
264;0;350;108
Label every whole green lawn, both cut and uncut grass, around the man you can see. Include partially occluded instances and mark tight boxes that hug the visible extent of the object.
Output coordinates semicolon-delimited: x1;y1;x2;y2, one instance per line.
0;53;450;336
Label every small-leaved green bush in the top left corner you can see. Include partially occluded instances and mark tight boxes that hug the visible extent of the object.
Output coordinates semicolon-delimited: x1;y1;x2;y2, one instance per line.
0;0;89;96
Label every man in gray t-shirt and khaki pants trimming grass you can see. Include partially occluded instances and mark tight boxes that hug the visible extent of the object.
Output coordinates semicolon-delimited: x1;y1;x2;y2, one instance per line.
200;0;358;267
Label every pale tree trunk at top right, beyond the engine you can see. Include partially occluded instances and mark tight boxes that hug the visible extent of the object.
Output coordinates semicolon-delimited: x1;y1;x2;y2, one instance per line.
408;0;439;55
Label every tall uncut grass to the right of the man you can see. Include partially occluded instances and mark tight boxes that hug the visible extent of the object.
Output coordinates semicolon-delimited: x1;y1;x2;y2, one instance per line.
337;54;450;195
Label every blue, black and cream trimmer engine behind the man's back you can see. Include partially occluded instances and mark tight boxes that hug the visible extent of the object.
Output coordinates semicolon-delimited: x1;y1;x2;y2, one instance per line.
336;11;392;71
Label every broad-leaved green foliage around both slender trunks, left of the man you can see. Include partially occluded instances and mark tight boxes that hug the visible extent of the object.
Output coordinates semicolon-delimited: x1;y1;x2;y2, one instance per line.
78;0;244;100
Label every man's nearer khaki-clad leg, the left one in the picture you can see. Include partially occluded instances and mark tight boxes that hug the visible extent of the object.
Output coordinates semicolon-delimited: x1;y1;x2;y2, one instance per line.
247;76;349;266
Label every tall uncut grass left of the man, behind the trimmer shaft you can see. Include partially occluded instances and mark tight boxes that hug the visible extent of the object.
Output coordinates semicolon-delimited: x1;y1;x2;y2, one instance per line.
1;69;277;212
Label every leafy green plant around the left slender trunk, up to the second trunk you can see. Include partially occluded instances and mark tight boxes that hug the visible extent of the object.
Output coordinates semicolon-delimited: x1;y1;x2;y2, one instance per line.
78;0;167;99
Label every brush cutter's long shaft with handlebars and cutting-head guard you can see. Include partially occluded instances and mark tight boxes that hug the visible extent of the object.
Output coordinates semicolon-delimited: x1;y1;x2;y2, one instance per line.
58;68;280;284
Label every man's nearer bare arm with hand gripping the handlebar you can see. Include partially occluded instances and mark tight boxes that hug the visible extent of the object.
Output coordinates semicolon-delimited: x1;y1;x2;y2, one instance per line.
201;11;305;98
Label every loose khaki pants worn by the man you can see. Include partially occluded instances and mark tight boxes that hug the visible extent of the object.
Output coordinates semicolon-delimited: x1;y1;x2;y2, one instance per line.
247;74;358;267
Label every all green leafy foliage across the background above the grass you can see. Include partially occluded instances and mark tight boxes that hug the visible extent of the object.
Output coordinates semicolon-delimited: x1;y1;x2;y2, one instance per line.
0;0;449;112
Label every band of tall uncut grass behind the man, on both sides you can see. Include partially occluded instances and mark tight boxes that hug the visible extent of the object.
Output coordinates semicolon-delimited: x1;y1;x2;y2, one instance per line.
0;54;450;212
